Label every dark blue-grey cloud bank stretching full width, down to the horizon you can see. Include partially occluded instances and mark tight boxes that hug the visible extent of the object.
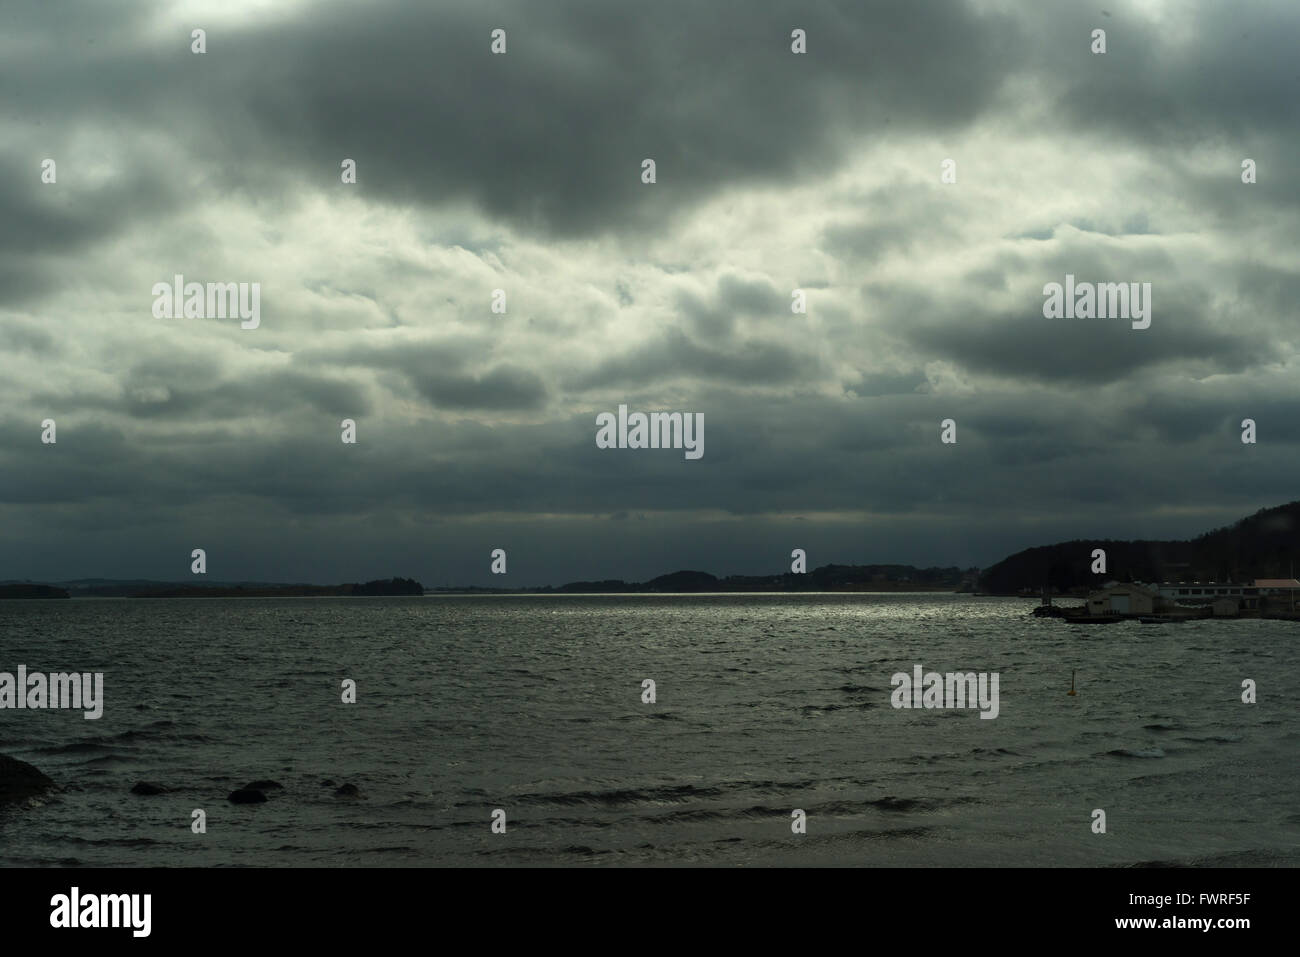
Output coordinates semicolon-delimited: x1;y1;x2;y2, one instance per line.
0;377;1300;584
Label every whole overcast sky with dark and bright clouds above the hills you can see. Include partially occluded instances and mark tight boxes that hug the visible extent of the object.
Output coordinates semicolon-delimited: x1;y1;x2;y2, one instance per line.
0;0;1300;585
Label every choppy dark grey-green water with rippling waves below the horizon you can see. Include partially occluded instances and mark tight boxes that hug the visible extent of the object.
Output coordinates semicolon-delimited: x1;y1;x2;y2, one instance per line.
0;594;1300;866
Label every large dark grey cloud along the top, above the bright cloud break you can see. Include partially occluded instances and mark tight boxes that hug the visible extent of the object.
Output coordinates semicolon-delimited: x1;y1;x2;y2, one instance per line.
0;0;1021;235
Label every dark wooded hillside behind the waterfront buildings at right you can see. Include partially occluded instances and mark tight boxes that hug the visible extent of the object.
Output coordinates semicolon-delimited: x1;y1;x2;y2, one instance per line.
980;502;1300;594
